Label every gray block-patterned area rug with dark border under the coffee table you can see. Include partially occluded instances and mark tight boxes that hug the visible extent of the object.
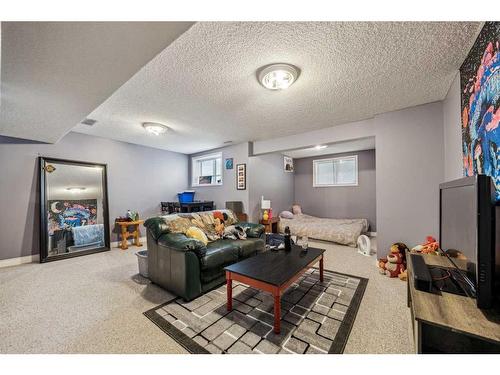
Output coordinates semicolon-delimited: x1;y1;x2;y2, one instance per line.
144;269;368;354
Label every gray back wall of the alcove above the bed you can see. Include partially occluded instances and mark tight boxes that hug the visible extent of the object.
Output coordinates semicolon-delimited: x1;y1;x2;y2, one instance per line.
294;150;377;231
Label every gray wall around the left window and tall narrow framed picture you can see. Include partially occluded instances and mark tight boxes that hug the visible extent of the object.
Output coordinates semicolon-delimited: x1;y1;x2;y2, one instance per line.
189;142;249;212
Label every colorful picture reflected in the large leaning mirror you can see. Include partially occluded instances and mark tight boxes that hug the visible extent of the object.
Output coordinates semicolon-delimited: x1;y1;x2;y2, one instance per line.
47;199;97;234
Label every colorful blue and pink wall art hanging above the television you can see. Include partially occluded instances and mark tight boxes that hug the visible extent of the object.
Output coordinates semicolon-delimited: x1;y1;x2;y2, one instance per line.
460;22;500;201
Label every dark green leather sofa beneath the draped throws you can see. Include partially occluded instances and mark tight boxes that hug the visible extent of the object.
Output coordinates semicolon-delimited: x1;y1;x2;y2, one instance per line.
144;214;265;301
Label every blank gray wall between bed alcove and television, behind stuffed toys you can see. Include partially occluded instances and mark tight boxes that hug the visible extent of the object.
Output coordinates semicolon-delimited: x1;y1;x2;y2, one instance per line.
375;102;444;256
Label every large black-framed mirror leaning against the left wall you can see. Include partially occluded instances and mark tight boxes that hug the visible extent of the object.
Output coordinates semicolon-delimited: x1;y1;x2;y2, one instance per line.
39;157;110;263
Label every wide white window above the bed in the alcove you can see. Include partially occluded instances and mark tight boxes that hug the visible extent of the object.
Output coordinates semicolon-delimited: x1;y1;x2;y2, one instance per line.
313;155;358;187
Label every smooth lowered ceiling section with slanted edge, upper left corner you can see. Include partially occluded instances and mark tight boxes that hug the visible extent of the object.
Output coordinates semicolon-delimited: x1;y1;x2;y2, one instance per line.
0;22;192;143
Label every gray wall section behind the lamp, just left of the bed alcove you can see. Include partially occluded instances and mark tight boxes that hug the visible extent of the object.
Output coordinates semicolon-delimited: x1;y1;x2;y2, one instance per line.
248;153;294;222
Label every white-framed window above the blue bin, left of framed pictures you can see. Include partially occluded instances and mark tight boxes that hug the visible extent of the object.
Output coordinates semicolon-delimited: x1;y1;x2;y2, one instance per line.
191;152;222;186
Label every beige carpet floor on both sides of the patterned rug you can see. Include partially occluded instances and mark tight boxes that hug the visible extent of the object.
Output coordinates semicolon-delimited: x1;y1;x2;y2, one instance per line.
0;239;413;353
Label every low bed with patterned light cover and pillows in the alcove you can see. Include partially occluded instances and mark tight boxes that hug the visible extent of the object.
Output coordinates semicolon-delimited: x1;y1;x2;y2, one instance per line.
278;205;368;247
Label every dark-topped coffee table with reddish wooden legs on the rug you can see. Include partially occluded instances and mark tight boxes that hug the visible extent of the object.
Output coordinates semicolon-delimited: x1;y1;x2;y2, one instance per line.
224;245;325;333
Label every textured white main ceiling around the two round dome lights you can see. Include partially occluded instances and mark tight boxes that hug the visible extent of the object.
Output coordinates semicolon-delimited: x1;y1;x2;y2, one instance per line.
74;22;480;153
